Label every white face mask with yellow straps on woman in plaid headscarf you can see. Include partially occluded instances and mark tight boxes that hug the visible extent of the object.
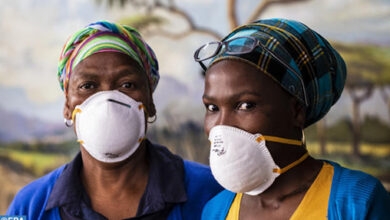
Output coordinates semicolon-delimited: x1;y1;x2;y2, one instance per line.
209;125;308;195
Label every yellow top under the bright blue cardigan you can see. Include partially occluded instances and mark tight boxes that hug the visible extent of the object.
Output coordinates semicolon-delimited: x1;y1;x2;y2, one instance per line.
226;162;333;220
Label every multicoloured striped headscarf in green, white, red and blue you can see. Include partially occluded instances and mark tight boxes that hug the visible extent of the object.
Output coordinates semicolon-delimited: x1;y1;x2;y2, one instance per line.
58;21;160;95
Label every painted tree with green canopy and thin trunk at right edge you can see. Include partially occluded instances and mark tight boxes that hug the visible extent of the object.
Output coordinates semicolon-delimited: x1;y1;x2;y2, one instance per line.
334;43;390;157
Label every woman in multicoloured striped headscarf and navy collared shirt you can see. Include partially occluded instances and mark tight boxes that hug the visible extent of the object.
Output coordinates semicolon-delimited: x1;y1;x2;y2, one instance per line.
7;22;221;219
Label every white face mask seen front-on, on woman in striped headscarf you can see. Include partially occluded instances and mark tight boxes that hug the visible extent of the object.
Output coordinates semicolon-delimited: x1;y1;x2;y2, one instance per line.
72;90;145;163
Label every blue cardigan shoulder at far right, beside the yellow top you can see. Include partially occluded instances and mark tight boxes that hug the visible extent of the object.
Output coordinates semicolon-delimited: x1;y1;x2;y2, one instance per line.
329;162;390;219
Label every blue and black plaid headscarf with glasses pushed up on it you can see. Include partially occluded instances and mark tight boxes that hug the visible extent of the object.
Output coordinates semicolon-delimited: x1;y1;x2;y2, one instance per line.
210;19;346;127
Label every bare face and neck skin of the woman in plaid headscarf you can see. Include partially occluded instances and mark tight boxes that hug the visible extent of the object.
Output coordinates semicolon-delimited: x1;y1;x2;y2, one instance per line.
203;59;322;220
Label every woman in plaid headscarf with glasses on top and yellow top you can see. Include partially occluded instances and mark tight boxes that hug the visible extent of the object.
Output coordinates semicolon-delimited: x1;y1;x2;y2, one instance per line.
195;19;390;220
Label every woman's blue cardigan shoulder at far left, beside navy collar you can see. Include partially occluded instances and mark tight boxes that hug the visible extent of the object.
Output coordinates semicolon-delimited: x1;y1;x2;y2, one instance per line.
7;165;65;218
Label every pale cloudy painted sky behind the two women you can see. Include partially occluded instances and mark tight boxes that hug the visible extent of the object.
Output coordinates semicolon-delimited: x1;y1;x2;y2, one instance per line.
0;0;390;127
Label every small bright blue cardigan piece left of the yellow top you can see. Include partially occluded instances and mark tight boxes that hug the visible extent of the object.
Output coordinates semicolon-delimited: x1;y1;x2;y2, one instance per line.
202;190;236;220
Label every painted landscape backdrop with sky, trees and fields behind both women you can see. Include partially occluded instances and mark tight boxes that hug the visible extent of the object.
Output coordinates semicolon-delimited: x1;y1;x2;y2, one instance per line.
0;0;390;215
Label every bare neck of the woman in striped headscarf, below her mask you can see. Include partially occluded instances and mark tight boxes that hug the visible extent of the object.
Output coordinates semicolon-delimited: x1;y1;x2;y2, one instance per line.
81;141;149;198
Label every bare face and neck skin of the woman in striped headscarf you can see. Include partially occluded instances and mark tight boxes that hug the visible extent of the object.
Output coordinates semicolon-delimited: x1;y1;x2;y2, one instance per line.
64;52;156;219
